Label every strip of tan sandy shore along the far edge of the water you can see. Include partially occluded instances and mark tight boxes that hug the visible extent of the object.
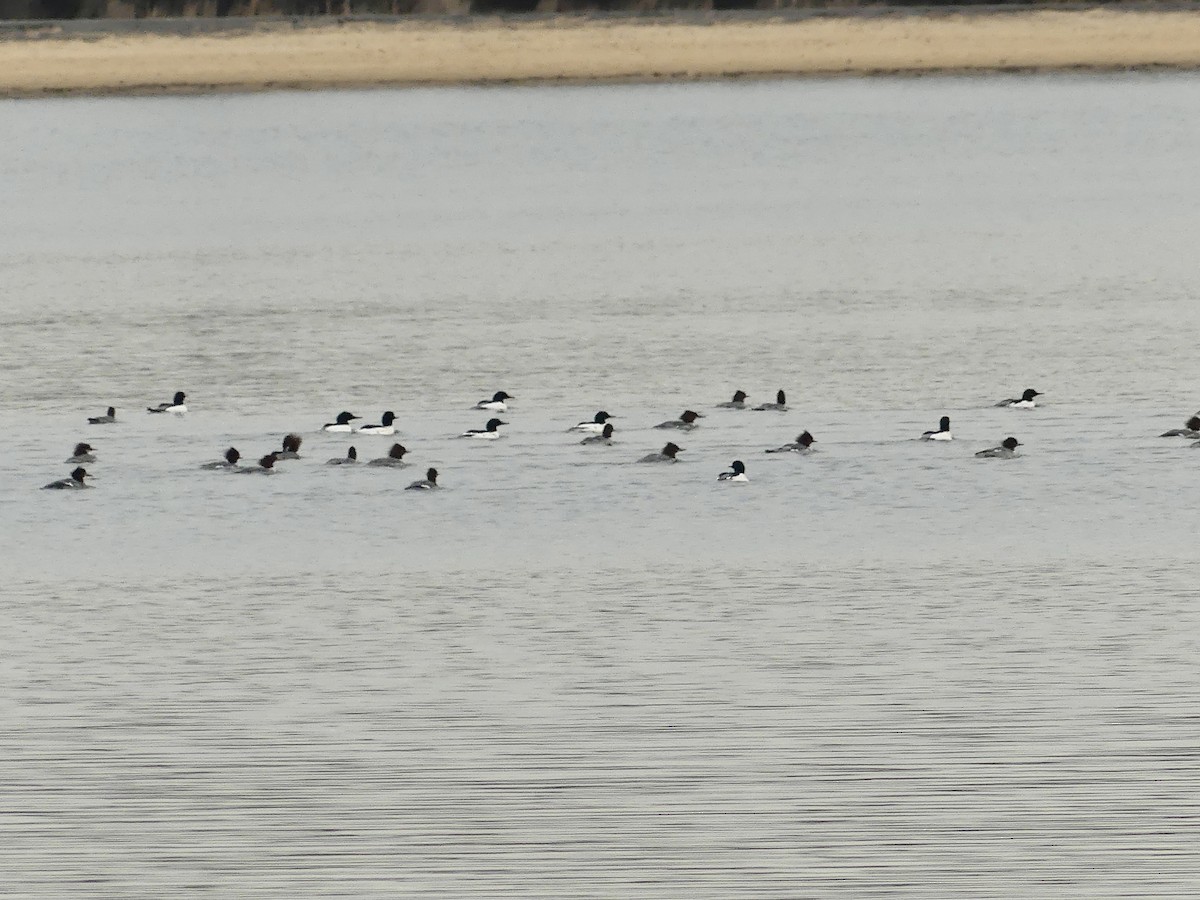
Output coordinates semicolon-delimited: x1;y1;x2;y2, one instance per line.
7;10;1200;97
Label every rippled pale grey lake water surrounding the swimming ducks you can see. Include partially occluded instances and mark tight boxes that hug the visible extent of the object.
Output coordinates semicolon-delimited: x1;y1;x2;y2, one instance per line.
0;74;1200;898
